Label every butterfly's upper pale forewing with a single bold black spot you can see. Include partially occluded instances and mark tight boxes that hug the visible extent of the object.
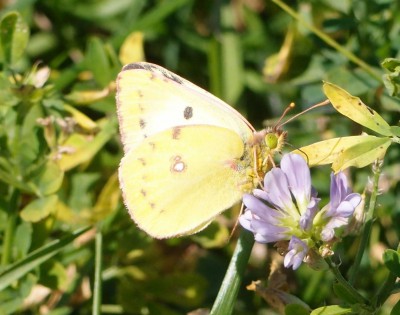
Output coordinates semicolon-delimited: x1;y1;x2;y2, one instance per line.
117;63;253;152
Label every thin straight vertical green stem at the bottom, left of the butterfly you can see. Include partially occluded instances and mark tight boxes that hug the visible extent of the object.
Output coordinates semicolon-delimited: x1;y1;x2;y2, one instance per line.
92;224;103;315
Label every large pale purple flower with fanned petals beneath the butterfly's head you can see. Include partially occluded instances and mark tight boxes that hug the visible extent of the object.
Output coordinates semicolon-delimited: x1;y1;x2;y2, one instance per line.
239;154;319;243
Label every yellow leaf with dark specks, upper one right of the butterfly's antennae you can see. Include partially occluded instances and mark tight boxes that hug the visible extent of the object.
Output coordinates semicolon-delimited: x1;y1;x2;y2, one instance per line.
323;82;393;136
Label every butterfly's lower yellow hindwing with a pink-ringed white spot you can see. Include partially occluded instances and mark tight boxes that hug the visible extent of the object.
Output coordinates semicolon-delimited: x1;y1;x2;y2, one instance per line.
119;125;250;238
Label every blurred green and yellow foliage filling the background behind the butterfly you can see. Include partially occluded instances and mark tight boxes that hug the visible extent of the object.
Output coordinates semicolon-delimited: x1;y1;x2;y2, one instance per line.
0;0;400;315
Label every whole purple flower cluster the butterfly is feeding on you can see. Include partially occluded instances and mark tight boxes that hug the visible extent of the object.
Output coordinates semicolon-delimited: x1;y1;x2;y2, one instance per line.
239;154;361;269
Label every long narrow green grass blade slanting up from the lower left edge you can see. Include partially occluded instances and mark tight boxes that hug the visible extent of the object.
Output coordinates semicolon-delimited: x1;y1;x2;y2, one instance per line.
0;227;89;291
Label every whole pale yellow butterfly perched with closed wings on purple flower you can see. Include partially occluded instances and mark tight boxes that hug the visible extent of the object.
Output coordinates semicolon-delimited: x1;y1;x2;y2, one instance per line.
116;62;286;238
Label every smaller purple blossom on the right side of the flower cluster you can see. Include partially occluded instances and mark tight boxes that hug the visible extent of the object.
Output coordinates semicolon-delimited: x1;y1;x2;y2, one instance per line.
321;172;361;242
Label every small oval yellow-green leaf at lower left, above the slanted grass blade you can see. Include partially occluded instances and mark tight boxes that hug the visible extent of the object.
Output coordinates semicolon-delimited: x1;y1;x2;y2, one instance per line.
20;195;58;222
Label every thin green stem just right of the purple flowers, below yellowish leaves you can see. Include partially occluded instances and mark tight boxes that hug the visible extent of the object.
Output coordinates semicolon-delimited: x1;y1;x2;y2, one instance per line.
349;161;382;284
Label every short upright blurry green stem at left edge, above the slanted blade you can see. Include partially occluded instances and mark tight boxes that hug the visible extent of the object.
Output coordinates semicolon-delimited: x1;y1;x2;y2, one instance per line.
1;188;19;266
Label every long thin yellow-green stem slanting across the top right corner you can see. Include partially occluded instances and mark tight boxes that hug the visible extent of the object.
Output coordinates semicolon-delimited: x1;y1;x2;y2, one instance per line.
272;0;382;83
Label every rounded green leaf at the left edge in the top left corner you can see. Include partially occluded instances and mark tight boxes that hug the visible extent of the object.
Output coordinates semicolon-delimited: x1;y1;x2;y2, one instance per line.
0;12;29;65
